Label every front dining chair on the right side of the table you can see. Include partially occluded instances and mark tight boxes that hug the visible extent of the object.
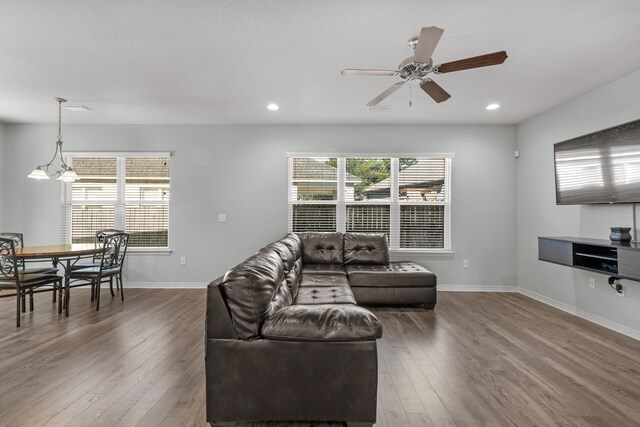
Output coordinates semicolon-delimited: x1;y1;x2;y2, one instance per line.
65;232;129;311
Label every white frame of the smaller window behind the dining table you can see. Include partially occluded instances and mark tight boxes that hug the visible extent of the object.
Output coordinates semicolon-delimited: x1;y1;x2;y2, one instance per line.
60;151;173;255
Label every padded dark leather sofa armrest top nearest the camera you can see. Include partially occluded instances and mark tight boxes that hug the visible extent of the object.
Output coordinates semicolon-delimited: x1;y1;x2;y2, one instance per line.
262;304;382;341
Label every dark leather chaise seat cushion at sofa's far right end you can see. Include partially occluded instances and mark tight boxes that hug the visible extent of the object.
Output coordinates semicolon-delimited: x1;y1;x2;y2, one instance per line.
345;261;436;288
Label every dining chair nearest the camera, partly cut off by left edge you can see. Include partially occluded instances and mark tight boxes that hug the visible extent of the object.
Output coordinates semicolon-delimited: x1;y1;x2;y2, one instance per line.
0;237;63;328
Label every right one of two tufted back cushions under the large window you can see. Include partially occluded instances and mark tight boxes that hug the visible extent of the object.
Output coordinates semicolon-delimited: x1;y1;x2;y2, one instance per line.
344;233;389;265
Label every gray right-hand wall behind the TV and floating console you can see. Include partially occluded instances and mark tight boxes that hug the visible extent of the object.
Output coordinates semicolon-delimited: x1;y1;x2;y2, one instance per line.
517;72;640;331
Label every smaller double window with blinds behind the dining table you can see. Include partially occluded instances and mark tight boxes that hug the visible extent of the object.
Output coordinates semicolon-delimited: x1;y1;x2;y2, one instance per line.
61;153;170;250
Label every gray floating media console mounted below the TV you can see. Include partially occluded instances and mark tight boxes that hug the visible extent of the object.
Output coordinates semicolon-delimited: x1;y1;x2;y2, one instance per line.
538;237;640;281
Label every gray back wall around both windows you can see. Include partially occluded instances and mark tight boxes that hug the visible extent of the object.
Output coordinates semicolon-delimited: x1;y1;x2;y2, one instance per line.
2;125;516;287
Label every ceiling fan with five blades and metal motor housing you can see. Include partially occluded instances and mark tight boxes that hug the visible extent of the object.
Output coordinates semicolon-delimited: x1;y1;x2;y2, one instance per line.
340;27;507;107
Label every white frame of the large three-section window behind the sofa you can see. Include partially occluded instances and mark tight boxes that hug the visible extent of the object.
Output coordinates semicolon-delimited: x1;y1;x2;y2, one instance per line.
287;152;455;255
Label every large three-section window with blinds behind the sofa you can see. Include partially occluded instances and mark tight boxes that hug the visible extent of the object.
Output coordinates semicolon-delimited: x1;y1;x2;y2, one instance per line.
288;154;453;252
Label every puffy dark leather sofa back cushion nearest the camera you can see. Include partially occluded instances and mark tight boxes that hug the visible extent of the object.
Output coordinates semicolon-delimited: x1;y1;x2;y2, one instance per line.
222;250;291;340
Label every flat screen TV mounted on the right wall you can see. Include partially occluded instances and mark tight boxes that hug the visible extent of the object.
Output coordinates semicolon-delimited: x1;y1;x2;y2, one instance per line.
554;120;640;205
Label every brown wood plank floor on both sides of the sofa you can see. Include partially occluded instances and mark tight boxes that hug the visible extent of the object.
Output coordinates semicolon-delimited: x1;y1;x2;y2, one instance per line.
0;289;640;427
